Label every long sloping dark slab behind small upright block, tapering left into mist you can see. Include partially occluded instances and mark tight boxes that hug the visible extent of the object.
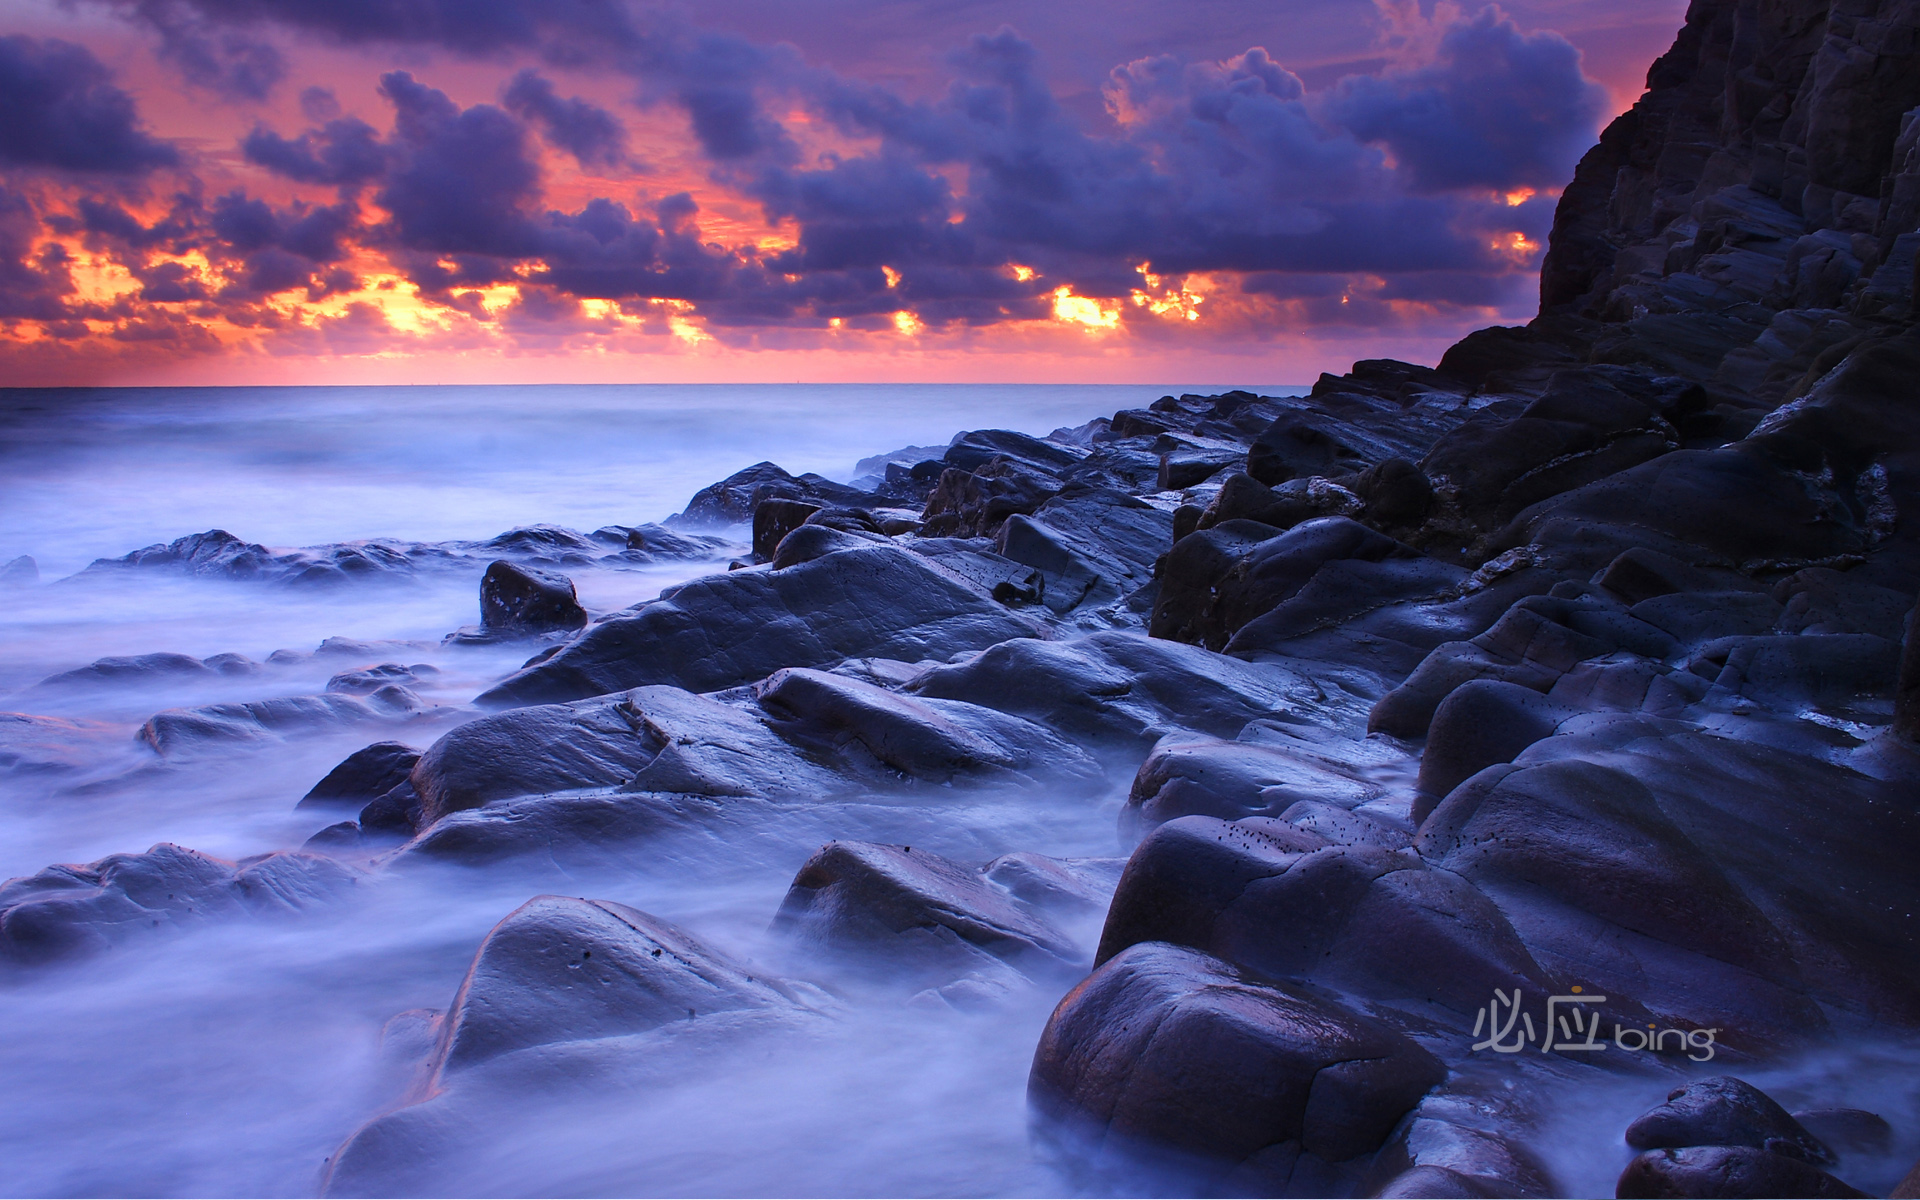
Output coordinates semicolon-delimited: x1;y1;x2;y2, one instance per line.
476;541;1039;707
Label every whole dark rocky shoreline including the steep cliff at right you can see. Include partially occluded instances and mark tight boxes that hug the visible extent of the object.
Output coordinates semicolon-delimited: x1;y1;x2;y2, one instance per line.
0;0;1920;1196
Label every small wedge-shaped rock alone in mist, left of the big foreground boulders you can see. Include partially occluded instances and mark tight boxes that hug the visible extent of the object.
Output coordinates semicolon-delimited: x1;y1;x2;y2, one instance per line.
774;841;1083;981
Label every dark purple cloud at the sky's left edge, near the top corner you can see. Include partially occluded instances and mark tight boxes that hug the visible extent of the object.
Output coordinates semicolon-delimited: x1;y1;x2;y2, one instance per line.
0;35;179;175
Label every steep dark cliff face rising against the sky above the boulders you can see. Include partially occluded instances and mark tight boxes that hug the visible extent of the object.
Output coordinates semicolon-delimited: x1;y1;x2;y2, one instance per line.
1530;0;1920;409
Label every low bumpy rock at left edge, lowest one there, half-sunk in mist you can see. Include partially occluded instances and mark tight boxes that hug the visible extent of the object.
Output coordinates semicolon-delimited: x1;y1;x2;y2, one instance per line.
0;841;359;964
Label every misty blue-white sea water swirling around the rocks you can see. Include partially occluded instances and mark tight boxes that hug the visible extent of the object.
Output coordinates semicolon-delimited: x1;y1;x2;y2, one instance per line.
0;386;1920;1196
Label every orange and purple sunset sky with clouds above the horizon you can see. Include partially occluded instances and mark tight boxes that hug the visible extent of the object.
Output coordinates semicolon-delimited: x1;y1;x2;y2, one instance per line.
0;0;1684;386
